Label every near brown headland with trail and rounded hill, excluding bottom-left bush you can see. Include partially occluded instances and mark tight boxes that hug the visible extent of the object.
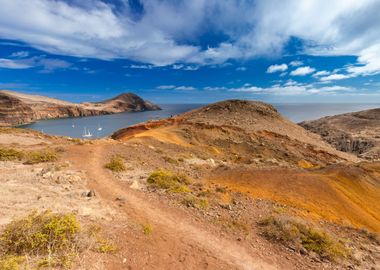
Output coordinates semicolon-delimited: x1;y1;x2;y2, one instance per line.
0;100;380;270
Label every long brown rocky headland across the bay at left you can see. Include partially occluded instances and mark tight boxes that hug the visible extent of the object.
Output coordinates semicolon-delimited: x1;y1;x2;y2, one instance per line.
0;90;160;126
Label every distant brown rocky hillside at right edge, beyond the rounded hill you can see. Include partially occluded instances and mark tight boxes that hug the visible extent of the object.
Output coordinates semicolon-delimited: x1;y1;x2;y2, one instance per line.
300;108;380;159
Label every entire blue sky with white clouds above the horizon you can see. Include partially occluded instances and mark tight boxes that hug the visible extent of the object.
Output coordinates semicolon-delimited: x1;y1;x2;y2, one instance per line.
0;0;380;103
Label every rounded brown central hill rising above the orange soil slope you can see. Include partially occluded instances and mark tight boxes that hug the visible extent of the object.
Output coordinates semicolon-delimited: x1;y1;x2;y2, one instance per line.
113;100;355;167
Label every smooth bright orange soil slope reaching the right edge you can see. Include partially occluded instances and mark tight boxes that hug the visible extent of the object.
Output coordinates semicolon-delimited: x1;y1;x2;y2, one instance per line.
208;164;380;232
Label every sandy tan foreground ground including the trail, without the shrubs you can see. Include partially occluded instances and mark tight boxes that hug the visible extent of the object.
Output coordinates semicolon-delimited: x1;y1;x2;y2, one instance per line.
0;131;379;269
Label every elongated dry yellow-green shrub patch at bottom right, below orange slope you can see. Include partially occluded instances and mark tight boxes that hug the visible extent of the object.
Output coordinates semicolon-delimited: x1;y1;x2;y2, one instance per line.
259;216;348;260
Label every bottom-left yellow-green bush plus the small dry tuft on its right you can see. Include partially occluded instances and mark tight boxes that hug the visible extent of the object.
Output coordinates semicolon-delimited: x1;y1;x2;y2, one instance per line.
0;211;116;270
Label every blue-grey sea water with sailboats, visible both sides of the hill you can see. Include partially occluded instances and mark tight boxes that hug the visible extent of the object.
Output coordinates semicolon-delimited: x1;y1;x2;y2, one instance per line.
21;103;380;138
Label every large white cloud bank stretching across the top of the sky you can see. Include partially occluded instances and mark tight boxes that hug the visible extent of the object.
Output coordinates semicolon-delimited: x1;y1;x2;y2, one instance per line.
0;0;380;70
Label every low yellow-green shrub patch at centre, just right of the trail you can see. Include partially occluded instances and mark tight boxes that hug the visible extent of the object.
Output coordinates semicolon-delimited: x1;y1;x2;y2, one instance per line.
147;170;191;193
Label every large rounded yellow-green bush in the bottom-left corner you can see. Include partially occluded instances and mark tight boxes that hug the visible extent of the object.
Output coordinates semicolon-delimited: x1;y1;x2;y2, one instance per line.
0;211;80;269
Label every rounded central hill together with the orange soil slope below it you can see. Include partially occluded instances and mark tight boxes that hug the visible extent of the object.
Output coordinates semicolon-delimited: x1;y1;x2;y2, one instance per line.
113;100;380;231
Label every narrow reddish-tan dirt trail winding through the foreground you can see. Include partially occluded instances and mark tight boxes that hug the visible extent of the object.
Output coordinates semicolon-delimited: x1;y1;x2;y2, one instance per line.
68;145;277;269
